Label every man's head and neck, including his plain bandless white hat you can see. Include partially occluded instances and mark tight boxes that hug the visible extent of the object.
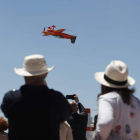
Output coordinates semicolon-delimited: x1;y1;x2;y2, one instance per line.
14;54;54;85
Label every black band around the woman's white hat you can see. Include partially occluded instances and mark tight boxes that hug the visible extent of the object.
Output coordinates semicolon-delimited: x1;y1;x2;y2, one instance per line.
104;74;127;86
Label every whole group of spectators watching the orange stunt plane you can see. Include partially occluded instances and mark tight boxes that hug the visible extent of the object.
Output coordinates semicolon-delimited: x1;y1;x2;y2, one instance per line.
0;55;140;140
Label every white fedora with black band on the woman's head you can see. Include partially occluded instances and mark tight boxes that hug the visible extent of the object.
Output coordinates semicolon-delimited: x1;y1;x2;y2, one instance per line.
95;60;135;88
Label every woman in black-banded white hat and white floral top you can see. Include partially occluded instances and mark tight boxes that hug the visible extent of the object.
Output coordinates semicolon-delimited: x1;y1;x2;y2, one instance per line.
93;60;140;140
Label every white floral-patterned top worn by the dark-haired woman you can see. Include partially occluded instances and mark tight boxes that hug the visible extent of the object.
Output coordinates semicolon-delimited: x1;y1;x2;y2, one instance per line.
96;91;140;140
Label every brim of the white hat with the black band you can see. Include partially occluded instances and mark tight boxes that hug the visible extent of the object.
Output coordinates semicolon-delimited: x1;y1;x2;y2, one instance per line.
94;72;135;88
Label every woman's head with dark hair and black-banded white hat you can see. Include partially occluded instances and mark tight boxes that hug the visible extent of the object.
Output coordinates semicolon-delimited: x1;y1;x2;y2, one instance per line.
95;60;135;105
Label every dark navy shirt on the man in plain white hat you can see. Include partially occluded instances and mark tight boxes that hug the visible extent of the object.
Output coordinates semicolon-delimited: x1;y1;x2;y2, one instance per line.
1;85;71;140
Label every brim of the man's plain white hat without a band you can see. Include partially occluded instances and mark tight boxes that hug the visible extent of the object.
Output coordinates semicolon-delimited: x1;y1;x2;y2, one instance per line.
14;66;55;76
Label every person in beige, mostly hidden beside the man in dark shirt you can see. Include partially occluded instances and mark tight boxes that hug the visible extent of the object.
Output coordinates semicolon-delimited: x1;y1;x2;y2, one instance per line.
60;121;73;140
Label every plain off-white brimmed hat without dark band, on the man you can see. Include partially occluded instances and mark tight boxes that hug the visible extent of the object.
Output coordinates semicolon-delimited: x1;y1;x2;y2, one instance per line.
14;54;55;76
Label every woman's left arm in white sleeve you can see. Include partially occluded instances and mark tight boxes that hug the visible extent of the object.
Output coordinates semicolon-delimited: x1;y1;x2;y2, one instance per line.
96;97;114;140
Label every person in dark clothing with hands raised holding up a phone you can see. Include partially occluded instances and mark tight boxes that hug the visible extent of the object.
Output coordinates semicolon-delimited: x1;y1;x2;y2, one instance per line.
67;94;88;140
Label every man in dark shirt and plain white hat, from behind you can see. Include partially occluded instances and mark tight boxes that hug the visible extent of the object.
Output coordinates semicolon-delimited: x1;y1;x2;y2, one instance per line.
1;55;71;140
